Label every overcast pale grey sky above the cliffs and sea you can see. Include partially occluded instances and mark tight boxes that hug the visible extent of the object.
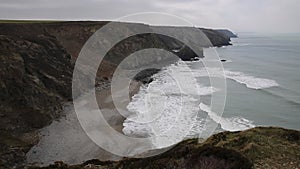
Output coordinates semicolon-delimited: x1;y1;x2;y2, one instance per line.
0;0;300;32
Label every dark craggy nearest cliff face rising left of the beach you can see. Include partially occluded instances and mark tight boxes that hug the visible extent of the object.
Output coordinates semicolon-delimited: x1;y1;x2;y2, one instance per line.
0;32;73;169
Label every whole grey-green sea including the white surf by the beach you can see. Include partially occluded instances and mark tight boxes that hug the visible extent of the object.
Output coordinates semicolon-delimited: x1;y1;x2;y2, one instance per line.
123;33;300;148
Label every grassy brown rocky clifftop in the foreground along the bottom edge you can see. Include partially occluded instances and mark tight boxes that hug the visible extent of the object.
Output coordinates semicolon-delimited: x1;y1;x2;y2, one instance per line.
27;127;300;169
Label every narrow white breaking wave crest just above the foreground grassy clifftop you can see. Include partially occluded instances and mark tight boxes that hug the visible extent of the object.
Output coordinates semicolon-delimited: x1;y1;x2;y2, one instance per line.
200;103;255;131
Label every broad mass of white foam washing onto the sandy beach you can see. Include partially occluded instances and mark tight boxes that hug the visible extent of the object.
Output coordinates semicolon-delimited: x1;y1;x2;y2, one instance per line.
123;62;217;148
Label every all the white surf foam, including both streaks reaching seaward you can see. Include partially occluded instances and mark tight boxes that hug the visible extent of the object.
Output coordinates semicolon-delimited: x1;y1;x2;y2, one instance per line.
123;62;270;148
